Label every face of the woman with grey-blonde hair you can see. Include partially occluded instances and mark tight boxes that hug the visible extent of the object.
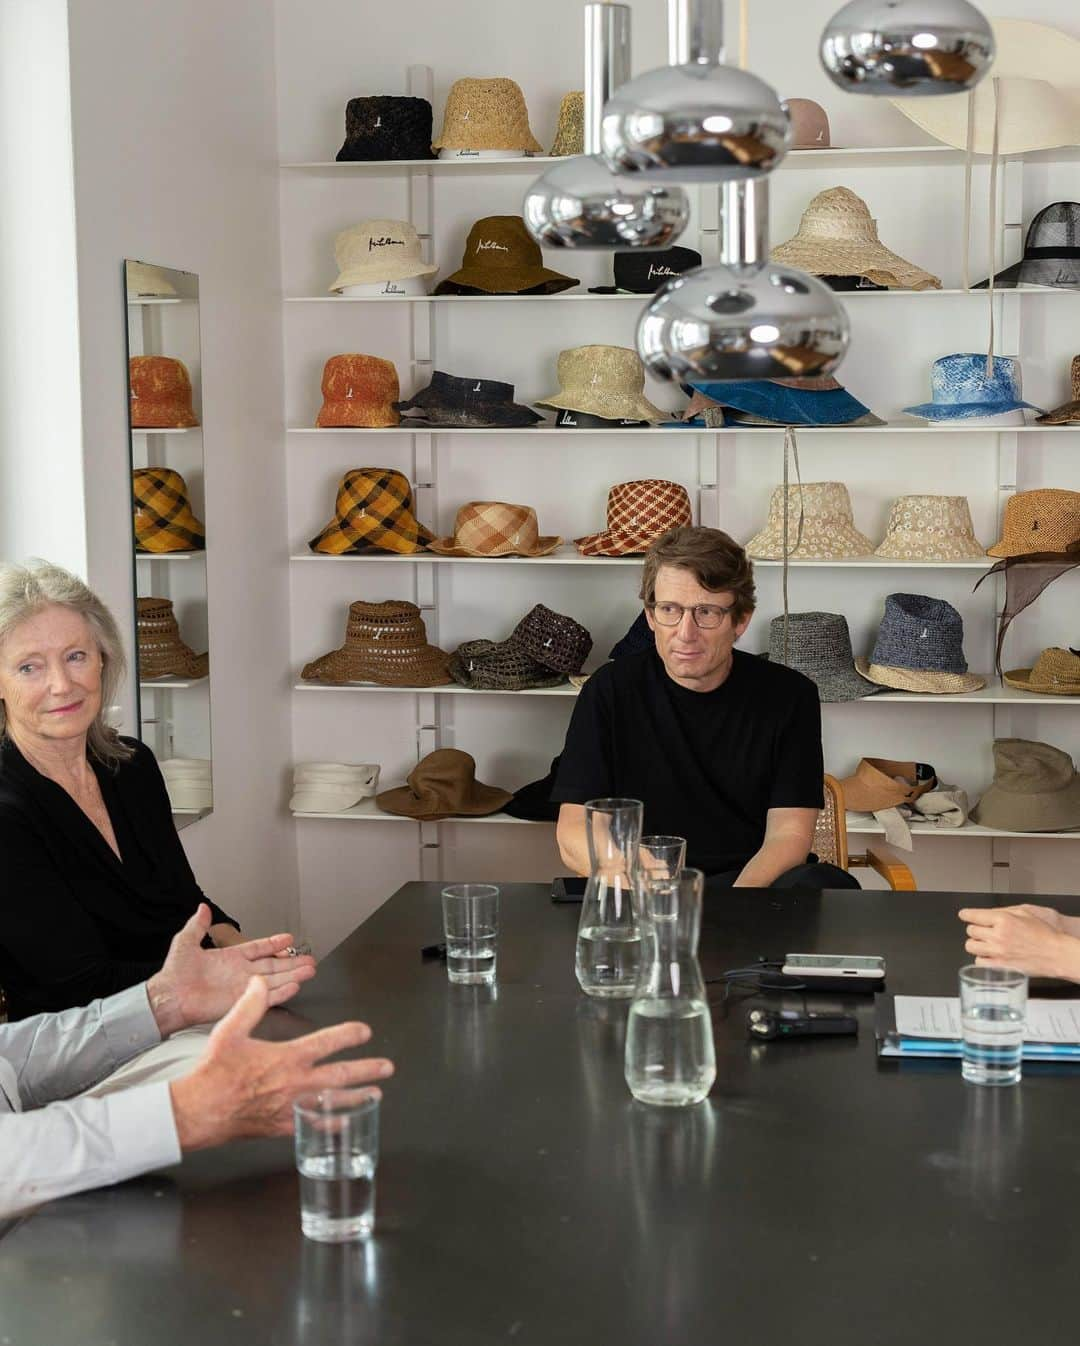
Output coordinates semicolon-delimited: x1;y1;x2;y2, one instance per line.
0;606;102;744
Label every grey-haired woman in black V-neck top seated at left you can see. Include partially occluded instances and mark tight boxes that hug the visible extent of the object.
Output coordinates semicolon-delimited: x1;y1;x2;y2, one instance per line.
0;564;241;1019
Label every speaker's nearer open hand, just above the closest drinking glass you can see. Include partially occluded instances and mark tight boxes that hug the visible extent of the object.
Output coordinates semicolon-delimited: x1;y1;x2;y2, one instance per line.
168;977;393;1151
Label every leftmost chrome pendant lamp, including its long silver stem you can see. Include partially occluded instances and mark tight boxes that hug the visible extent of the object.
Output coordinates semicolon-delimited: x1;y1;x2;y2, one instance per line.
521;4;689;249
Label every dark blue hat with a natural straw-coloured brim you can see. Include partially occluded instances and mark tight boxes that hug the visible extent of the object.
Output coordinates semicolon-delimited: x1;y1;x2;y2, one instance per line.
855;594;986;693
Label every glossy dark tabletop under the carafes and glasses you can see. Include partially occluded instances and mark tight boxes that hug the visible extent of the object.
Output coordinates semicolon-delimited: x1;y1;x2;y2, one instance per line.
0;883;1080;1346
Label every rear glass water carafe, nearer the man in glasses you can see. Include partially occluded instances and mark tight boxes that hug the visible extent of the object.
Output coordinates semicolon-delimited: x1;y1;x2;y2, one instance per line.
574;800;644;1000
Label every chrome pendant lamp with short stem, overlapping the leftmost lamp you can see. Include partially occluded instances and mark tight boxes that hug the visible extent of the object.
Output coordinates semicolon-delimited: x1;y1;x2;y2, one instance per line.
601;0;788;182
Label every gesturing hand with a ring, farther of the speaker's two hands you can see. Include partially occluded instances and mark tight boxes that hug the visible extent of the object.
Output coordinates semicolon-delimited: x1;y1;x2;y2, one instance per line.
147;902;315;1038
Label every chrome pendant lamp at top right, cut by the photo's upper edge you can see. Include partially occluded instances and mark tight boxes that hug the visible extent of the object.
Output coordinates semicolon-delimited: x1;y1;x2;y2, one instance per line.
821;0;995;98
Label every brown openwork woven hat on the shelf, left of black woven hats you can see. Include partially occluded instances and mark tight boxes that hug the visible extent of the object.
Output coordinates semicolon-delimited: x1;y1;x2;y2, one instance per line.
300;602;450;686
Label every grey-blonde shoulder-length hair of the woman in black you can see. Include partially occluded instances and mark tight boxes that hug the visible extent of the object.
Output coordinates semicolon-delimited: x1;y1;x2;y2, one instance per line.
0;561;133;767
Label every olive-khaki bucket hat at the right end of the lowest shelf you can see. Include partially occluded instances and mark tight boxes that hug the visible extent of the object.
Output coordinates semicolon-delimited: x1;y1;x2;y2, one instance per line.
971;739;1080;832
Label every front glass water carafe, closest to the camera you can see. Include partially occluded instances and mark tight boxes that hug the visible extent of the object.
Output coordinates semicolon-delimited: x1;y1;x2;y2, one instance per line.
625;870;716;1108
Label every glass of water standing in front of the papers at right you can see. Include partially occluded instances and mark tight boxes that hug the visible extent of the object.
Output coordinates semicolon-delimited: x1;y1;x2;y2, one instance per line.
960;962;1027;1085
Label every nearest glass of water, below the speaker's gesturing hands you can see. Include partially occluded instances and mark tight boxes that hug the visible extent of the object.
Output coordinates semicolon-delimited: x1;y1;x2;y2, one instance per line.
292;1089;380;1244
